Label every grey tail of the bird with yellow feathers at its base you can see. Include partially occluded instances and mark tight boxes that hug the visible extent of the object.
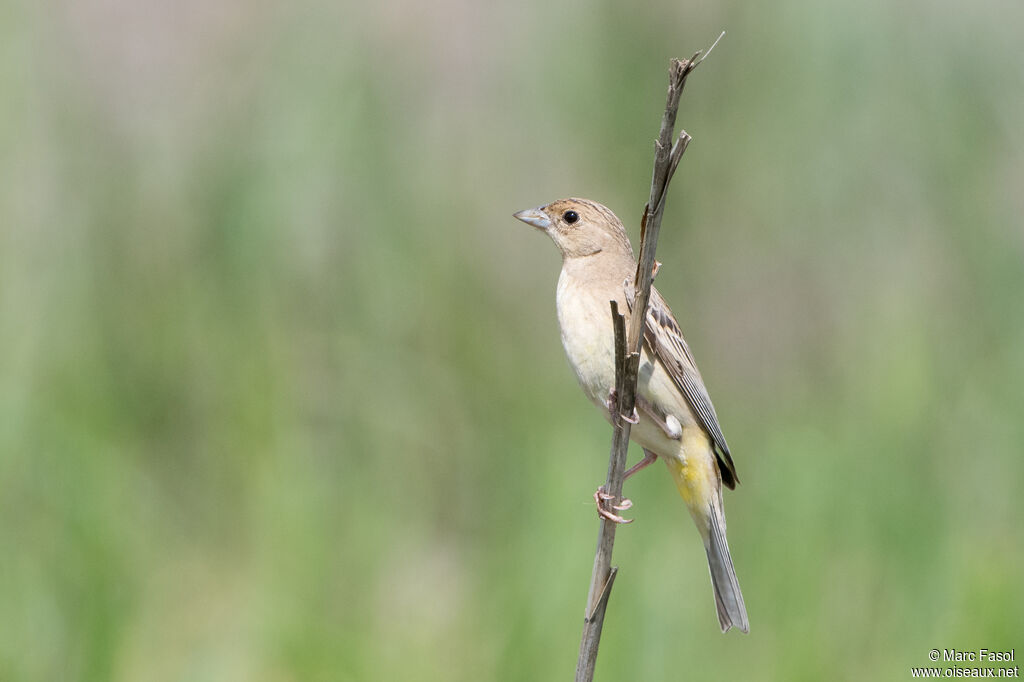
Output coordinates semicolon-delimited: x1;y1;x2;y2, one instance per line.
664;450;751;632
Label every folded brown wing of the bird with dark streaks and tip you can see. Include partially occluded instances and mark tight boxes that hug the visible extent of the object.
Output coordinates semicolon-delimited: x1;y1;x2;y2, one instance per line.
626;281;739;488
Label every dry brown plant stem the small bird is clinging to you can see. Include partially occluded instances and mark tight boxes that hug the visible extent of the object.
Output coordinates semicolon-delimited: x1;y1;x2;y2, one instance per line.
575;34;724;682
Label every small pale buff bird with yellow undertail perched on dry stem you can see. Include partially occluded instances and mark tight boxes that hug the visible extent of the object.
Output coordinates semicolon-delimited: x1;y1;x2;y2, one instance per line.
513;198;750;633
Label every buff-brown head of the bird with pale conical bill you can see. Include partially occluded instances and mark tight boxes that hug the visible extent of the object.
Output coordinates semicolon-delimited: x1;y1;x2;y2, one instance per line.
513;199;633;259
